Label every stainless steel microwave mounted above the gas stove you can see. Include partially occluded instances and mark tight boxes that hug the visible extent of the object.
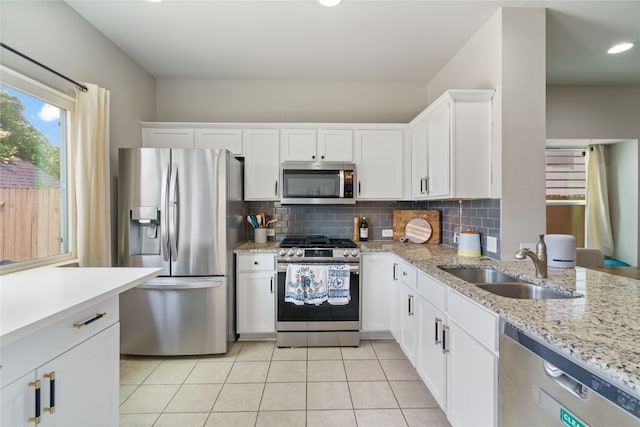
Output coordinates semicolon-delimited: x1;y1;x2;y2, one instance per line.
280;162;356;205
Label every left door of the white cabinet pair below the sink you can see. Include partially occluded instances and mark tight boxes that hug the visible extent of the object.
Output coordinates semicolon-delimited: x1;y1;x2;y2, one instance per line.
416;296;447;409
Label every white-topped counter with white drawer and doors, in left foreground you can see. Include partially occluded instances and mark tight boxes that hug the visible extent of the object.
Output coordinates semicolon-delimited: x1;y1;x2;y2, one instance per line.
0;267;161;426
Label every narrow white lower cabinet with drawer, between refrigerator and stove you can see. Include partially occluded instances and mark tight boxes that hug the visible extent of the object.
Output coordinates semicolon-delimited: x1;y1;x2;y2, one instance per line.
236;254;278;334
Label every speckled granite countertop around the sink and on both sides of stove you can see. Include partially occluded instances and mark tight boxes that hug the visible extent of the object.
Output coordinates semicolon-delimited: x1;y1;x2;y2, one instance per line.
236;240;640;397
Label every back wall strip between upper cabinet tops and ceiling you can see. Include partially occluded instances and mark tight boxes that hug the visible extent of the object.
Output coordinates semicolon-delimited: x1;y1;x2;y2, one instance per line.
157;79;428;123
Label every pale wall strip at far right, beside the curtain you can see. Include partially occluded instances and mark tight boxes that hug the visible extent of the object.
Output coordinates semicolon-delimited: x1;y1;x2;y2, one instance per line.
605;140;640;266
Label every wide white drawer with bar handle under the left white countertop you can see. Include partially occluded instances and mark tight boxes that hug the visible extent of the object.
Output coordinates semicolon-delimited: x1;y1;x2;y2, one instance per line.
0;296;120;387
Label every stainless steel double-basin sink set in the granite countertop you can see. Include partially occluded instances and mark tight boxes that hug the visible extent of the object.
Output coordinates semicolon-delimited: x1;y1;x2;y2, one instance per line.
440;267;574;299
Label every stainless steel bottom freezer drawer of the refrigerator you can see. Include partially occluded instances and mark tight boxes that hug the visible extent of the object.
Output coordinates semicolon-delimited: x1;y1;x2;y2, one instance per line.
120;277;227;356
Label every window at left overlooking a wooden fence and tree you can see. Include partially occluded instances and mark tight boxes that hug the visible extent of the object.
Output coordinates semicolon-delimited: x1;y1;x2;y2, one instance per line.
0;68;74;271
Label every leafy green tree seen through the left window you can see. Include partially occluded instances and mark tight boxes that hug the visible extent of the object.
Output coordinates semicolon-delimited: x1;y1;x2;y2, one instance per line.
0;90;60;179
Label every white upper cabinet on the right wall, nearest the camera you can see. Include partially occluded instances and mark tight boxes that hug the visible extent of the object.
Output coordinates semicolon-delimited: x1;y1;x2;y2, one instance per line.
409;90;494;200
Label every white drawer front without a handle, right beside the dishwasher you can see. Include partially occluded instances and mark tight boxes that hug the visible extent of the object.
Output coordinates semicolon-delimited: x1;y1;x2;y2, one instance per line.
447;289;498;353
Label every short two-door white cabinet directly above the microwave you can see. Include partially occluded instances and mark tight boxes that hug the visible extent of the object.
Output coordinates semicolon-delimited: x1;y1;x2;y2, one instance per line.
280;129;353;162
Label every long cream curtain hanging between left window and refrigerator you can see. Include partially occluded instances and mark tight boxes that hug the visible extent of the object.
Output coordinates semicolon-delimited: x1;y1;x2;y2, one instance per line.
69;84;111;267
